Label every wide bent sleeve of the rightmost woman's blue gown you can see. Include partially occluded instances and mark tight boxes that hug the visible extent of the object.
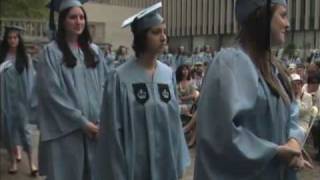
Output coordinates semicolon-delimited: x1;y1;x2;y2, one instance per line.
196;50;278;179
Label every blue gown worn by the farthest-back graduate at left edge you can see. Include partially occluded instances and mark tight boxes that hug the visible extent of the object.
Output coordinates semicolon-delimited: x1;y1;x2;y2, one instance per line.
1;58;35;152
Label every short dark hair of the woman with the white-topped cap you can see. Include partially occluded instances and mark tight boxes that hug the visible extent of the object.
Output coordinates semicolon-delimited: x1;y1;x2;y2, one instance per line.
132;28;151;57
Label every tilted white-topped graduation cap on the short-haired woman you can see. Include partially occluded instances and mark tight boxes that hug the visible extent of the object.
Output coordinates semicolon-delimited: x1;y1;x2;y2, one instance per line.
121;2;163;33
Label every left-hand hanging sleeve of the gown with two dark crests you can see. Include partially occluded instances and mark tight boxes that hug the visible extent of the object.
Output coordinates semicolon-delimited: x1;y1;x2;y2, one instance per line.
96;71;128;180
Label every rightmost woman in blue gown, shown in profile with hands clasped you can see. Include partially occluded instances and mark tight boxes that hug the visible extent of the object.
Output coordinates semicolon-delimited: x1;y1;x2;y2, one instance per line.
194;0;310;180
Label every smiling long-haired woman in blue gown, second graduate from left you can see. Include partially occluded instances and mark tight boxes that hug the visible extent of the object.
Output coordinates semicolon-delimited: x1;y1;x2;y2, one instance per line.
36;0;108;180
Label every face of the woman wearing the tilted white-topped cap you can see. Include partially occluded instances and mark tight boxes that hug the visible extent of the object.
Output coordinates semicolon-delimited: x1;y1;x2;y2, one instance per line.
146;24;167;54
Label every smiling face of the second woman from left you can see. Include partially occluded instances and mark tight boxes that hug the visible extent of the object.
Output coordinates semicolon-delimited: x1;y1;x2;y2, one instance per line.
64;7;86;36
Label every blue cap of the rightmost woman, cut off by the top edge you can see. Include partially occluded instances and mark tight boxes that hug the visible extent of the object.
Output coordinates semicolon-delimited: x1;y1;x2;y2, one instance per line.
236;0;287;24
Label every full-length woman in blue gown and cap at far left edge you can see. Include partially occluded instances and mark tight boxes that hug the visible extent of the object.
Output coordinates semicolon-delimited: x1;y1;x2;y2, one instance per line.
0;26;37;176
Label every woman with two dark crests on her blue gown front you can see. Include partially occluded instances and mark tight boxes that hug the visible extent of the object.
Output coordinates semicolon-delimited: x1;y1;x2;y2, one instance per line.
96;3;190;180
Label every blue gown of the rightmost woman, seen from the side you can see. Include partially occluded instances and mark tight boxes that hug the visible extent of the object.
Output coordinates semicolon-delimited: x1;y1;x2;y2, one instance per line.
194;48;304;180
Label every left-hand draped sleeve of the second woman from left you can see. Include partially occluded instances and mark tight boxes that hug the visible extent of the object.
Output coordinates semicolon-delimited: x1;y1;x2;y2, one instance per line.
36;46;88;140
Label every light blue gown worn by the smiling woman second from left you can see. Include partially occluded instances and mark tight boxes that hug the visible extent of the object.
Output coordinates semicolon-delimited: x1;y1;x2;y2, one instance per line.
37;41;108;180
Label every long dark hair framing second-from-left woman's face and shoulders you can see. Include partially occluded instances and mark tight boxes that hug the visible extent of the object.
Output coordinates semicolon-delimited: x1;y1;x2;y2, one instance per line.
56;7;99;68
